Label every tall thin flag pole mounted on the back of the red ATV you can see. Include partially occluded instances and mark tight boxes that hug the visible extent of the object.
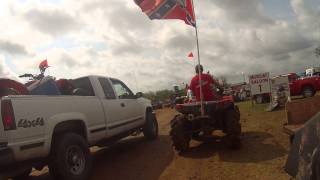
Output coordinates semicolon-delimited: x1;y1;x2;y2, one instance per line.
191;0;204;116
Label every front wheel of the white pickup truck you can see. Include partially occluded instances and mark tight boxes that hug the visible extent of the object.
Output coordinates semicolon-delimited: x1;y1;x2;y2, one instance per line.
143;112;158;140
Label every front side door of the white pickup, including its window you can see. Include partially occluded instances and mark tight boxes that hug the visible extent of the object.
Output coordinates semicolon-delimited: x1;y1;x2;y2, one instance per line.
99;78;143;136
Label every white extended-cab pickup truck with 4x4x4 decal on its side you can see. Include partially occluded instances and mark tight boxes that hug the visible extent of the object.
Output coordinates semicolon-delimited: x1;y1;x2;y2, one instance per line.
0;76;158;180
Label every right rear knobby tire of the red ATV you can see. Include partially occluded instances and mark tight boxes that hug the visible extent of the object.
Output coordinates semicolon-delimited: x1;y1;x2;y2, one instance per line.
225;106;241;149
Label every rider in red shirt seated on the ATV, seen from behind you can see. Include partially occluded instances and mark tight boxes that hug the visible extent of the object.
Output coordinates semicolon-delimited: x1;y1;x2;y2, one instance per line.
190;65;217;101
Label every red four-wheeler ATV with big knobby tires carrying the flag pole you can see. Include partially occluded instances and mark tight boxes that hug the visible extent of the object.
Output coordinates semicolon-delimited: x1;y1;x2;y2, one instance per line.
170;97;241;152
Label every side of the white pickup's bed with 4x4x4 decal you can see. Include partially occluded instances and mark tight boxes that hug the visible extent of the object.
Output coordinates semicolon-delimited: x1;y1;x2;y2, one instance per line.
0;95;106;160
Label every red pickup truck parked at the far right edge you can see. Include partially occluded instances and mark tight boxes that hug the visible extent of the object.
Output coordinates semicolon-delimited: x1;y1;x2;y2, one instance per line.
288;73;320;97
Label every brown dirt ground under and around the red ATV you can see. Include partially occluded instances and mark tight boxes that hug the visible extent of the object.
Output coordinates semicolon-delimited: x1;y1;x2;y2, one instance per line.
31;102;290;180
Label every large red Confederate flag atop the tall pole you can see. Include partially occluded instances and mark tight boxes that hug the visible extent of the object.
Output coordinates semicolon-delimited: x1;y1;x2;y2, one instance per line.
134;0;196;27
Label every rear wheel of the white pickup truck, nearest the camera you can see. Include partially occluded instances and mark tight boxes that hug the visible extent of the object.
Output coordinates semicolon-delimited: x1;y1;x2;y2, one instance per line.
49;133;92;180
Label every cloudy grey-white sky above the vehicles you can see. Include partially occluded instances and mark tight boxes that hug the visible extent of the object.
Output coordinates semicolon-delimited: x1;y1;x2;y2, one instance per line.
0;0;320;91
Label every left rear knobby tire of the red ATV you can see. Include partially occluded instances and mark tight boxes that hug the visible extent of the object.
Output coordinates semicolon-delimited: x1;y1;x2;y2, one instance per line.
170;115;192;152
